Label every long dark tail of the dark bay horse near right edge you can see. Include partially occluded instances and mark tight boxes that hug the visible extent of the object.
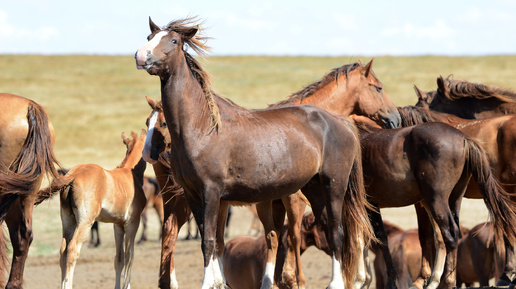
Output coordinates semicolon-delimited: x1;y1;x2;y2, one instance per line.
465;138;516;248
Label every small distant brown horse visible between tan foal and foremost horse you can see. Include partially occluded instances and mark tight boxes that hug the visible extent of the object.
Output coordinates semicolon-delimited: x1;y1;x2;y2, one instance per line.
137;177;164;245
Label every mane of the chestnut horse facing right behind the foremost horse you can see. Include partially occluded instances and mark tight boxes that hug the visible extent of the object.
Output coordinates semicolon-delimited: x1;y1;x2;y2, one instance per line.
269;62;361;107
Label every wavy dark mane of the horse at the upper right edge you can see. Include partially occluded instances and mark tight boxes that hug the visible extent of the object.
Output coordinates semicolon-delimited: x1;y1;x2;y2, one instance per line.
444;77;516;102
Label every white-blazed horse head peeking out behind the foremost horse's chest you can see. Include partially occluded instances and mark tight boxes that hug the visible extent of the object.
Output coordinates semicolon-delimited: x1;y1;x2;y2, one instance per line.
143;97;171;164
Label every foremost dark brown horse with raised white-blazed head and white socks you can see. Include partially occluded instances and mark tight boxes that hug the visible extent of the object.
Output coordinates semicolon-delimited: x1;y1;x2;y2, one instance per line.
135;19;371;288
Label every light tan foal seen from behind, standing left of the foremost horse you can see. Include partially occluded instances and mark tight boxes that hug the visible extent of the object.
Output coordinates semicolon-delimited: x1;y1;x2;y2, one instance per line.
38;130;147;289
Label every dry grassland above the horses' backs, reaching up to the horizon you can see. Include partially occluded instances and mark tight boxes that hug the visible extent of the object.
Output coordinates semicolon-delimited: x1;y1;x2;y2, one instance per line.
0;55;516;168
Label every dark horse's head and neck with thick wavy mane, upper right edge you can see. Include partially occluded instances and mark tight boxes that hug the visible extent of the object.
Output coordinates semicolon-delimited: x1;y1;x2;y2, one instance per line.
423;76;516;119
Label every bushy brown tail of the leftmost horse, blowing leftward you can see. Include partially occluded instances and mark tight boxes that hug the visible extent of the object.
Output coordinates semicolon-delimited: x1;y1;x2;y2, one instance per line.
0;101;60;216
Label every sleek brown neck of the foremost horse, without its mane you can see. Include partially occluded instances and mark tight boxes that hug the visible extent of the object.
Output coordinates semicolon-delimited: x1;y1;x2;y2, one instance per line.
161;56;210;142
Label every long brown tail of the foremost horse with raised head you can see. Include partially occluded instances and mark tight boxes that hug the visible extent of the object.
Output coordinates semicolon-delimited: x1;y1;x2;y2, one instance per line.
342;123;376;288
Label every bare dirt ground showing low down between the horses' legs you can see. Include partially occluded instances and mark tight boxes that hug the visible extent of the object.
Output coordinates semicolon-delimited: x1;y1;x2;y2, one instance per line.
24;200;487;289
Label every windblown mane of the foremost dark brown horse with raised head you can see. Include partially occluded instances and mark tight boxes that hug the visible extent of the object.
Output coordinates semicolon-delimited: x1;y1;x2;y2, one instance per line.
164;17;221;128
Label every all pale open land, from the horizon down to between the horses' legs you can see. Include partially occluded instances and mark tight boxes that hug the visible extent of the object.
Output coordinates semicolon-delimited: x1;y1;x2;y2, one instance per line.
0;53;516;288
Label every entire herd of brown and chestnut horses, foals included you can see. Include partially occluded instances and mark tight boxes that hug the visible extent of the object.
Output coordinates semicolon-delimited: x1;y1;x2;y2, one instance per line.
0;18;516;289
